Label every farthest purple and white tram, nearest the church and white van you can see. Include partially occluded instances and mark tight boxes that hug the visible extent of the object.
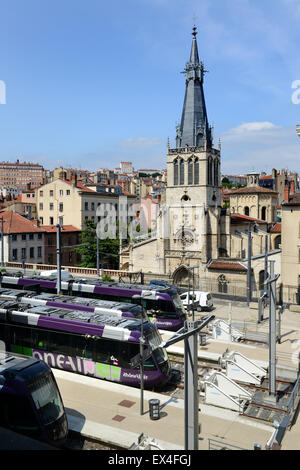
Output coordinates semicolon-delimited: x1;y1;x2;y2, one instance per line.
0;274;186;331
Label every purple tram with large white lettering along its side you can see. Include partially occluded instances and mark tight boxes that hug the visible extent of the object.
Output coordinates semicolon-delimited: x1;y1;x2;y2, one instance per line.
0;299;171;388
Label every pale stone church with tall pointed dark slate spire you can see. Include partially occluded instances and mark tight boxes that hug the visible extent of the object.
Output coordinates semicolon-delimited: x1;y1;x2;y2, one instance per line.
120;27;278;291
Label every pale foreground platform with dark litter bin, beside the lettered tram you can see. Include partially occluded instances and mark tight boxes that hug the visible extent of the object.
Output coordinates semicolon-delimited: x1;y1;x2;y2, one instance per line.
53;369;273;450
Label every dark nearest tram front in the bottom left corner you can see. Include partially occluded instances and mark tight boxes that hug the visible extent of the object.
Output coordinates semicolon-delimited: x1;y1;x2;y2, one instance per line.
0;350;68;447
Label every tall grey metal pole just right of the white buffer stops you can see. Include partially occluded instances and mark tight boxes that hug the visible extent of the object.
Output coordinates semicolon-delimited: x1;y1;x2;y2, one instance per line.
269;261;276;396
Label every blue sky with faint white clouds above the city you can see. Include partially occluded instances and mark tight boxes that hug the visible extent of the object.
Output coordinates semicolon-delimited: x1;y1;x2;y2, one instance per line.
0;0;300;174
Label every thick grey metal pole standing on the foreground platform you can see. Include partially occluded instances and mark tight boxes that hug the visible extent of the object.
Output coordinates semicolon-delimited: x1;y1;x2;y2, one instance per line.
184;321;199;450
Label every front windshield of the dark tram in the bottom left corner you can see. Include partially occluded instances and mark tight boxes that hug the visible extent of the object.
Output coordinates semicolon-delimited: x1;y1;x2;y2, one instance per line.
28;372;64;426
